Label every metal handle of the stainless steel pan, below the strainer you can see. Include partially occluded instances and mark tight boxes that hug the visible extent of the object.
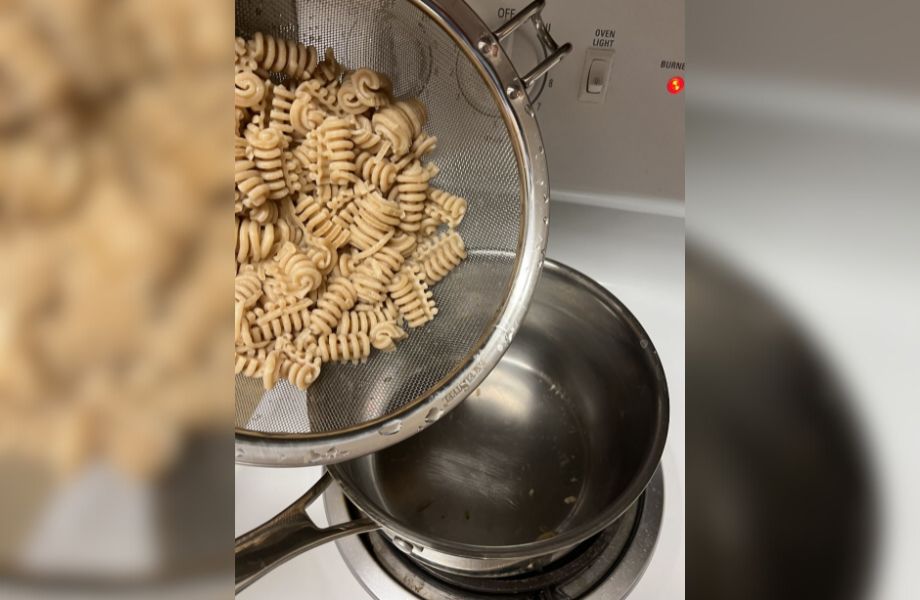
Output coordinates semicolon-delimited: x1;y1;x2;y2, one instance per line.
241;471;380;594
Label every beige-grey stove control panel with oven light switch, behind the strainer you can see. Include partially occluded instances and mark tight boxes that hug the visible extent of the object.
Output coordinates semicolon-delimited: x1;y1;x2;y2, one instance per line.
467;0;692;206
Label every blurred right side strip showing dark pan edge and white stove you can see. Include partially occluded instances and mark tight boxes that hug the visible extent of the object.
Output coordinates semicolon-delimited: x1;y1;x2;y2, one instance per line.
686;0;920;600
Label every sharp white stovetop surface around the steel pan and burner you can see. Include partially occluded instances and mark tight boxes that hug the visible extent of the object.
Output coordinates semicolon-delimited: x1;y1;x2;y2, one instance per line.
236;202;685;600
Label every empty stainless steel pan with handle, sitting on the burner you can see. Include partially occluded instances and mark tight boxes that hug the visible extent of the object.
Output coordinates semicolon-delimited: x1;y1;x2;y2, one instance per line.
236;261;668;590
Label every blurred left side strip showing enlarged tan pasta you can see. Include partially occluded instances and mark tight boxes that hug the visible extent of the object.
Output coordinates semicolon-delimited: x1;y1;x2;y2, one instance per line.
0;0;234;598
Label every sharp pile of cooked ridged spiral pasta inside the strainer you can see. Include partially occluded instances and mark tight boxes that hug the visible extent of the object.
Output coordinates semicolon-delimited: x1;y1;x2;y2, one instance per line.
234;33;467;390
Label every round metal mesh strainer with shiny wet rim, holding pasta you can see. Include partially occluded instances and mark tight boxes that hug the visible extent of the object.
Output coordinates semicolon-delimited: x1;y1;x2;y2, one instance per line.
236;0;569;466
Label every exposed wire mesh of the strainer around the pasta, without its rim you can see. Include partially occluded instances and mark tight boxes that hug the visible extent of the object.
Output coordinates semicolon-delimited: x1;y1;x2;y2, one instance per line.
236;0;523;437
